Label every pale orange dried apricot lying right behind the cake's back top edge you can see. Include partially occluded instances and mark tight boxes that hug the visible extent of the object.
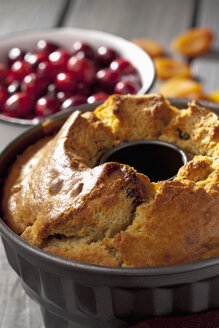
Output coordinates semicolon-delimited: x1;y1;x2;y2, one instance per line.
159;77;203;99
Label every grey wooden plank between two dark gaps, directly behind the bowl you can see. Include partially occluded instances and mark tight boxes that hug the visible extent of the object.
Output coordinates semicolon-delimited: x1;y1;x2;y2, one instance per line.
64;0;194;50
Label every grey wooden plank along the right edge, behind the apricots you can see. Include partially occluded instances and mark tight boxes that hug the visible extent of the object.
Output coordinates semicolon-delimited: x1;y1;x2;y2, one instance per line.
192;0;219;93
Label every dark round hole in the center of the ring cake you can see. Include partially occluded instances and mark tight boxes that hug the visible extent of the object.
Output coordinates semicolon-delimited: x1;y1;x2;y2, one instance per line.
100;140;188;182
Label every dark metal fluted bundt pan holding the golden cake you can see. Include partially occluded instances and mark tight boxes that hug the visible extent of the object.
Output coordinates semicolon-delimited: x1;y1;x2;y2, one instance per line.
0;99;219;328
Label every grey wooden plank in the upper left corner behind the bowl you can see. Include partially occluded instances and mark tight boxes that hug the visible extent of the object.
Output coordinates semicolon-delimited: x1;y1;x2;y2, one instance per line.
0;0;65;36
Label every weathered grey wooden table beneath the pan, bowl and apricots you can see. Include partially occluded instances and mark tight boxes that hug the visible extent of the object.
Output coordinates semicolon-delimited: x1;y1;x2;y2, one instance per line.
0;0;219;328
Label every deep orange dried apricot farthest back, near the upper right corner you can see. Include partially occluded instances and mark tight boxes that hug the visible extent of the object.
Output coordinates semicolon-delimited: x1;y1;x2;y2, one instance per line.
172;27;213;57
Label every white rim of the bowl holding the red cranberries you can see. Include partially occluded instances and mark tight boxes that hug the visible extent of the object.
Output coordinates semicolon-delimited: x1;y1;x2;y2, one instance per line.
0;27;156;126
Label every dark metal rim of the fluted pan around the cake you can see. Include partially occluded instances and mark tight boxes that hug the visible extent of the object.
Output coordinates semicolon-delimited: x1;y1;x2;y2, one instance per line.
0;98;219;277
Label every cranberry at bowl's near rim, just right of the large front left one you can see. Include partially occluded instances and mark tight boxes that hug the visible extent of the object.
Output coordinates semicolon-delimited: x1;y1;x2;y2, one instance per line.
35;96;59;117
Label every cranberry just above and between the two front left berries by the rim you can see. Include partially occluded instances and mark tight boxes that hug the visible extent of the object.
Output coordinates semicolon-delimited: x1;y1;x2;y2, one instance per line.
21;73;49;98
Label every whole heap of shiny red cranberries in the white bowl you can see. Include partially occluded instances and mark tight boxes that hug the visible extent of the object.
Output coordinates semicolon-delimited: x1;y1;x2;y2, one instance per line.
0;40;141;119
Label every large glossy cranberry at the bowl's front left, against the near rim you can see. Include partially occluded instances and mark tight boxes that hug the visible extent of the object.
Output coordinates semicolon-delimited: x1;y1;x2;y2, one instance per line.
3;92;34;118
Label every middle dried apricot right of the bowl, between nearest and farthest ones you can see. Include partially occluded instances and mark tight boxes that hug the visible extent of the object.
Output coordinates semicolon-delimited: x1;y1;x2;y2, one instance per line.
154;57;190;79
